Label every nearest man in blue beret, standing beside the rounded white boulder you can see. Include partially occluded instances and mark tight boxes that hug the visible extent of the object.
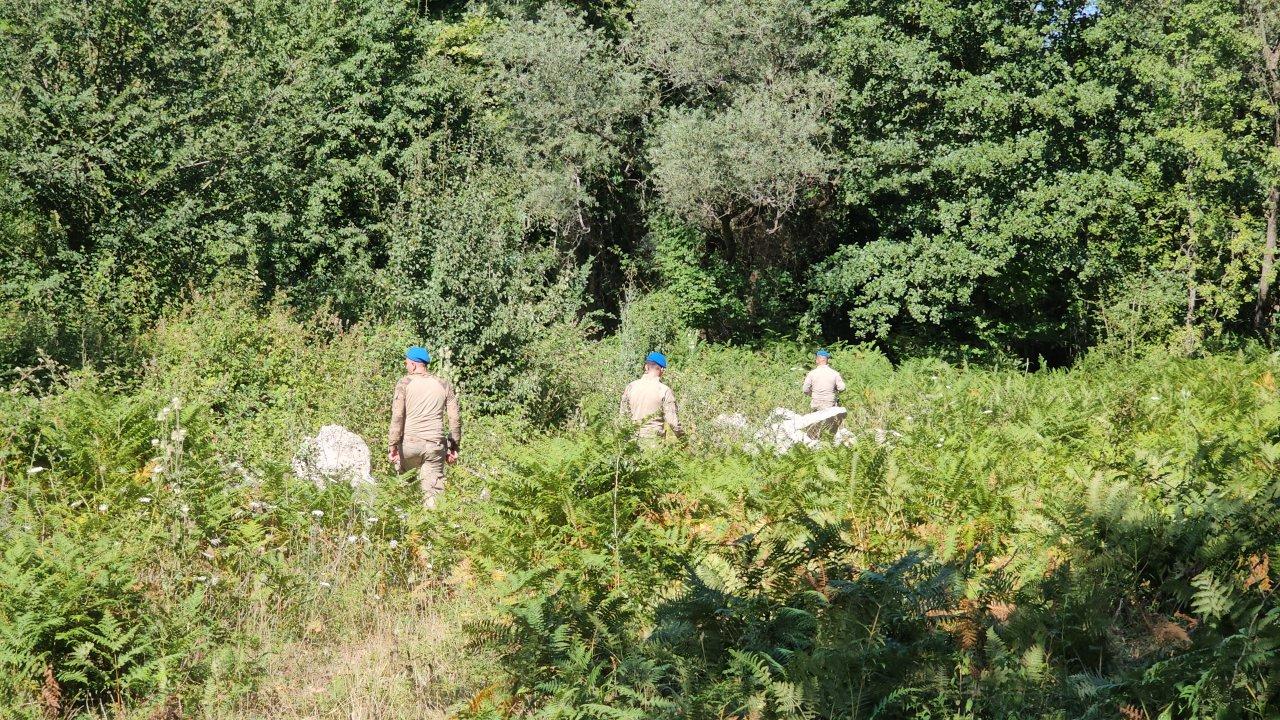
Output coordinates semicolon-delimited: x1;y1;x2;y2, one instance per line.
387;346;462;509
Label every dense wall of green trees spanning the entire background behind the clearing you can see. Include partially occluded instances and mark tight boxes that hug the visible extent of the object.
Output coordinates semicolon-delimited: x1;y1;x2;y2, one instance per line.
0;0;1280;379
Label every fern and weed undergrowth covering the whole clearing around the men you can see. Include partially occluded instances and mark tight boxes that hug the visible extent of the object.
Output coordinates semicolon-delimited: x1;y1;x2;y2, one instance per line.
0;297;1280;719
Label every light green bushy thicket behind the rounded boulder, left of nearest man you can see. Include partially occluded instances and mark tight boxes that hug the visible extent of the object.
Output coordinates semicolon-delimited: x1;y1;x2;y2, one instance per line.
142;288;419;465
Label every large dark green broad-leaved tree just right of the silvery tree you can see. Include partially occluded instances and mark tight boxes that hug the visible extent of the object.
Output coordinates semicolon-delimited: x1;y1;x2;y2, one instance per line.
812;0;1125;356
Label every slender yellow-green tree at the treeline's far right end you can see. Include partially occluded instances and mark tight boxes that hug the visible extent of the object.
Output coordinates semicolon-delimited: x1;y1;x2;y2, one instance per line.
1100;0;1270;347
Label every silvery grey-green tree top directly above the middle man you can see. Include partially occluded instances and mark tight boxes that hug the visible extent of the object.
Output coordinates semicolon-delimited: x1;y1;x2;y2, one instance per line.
632;0;837;257
